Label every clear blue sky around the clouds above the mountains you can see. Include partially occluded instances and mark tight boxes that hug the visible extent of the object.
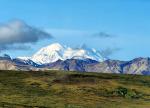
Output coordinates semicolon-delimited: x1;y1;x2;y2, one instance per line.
0;0;150;60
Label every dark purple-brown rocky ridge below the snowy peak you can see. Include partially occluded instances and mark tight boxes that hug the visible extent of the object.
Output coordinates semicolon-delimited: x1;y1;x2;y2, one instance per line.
0;55;150;75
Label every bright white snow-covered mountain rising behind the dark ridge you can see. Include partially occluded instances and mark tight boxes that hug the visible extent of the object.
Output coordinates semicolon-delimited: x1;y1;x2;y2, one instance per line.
31;43;104;64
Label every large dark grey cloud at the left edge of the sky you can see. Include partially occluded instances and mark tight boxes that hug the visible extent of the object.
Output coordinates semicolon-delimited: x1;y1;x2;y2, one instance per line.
0;20;52;50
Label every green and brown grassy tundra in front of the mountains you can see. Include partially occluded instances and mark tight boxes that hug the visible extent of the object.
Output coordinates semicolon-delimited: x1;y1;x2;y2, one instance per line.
0;71;150;108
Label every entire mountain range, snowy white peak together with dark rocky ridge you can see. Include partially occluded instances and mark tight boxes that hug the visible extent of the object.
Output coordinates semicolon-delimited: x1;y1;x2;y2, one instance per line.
0;43;150;75
